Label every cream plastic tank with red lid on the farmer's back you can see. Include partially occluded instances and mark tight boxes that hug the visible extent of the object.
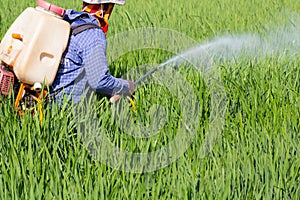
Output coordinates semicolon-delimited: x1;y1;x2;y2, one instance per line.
0;0;70;85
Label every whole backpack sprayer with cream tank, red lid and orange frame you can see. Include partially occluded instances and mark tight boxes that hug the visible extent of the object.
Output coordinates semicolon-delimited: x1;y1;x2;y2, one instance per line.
0;0;70;118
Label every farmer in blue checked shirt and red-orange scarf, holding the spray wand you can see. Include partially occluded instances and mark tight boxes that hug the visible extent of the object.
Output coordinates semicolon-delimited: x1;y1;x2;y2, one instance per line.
50;0;134;103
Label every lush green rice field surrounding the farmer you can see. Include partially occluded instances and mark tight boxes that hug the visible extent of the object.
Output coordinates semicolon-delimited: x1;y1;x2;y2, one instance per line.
0;0;300;199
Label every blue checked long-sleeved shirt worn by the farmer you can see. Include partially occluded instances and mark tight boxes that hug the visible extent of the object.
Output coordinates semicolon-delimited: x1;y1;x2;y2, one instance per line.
50;10;130;103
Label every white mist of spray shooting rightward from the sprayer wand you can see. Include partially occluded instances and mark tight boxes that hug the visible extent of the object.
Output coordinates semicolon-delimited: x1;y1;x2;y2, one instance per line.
135;19;300;84
